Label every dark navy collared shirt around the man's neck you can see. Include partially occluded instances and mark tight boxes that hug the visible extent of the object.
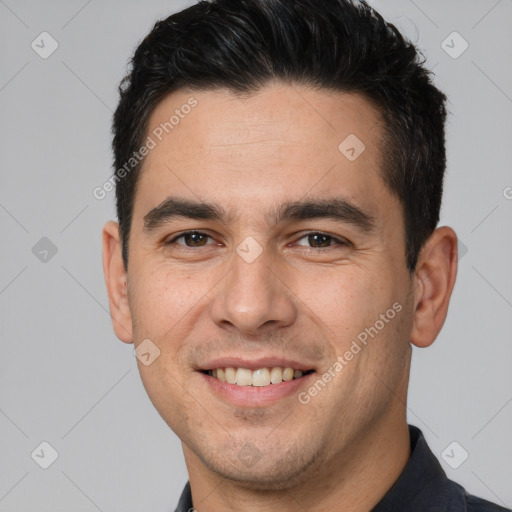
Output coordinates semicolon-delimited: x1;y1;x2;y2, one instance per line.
176;425;511;512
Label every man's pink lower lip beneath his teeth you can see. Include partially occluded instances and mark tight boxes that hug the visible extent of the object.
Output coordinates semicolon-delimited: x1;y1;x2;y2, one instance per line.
198;372;315;407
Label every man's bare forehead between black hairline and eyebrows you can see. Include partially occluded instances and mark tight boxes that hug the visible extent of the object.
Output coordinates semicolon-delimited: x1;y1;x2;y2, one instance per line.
134;83;389;224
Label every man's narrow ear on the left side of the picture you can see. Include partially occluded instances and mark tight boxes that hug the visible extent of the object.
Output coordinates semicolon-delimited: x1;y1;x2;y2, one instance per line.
103;221;133;343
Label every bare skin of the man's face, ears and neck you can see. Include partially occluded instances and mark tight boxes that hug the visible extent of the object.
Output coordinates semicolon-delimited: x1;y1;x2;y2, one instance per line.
103;83;457;512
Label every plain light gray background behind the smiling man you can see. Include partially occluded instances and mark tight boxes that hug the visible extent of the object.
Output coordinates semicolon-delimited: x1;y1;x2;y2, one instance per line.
0;0;512;512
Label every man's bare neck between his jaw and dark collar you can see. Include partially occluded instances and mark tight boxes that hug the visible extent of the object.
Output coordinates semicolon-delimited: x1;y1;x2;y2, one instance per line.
183;414;410;512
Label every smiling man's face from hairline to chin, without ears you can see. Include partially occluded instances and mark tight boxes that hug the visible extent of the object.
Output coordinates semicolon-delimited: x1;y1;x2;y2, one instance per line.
115;83;413;489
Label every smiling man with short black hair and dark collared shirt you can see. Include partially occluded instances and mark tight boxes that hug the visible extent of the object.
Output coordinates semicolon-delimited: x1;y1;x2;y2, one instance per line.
103;0;505;512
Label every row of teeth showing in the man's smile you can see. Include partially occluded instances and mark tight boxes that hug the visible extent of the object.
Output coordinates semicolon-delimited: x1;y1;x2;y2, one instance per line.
208;367;303;387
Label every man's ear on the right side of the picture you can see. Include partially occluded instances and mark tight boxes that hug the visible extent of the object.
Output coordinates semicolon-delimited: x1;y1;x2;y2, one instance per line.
411;227;458;347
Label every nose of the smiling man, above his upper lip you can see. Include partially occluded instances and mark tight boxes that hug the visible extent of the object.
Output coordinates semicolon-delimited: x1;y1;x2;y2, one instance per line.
211;244;297;335
